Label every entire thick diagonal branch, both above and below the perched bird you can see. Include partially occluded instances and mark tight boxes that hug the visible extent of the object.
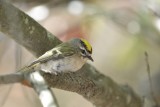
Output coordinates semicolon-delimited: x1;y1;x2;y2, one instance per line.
0;0;143;107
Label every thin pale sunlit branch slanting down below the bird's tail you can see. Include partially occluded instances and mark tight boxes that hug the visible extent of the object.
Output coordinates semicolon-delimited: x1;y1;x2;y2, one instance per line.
25;71;59;107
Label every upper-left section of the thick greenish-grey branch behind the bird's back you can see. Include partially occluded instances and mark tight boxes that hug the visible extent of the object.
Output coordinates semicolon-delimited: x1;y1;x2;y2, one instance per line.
0;0;61;56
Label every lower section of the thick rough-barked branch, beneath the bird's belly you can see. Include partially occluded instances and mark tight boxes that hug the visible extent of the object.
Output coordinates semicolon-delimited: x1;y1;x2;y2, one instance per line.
43;64;142;107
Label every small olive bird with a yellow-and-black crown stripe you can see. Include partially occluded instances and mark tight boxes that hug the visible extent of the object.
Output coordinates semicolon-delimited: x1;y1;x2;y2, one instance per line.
29;38;93;75
